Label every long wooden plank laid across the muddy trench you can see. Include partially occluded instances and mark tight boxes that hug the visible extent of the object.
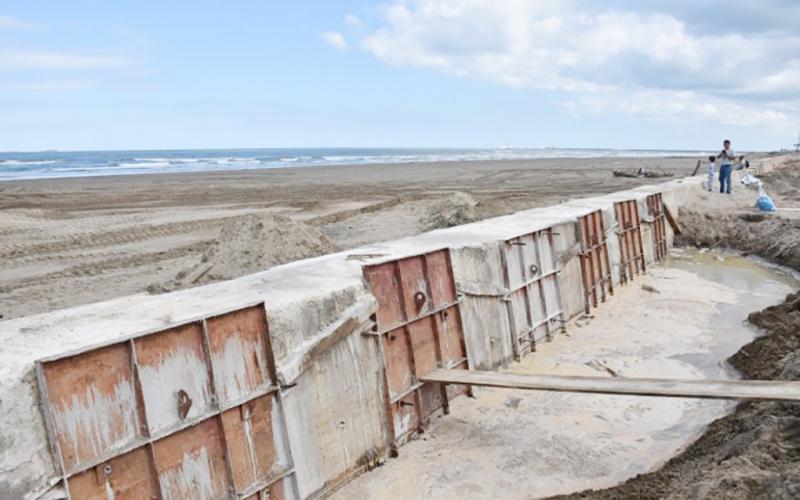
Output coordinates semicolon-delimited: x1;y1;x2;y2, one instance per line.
420;369;800;401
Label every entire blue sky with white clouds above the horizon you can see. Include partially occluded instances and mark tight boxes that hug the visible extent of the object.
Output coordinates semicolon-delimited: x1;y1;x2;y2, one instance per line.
0;0;800;151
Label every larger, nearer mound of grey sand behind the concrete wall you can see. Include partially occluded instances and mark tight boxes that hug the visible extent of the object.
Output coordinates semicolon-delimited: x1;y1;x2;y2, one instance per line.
149;215;339;293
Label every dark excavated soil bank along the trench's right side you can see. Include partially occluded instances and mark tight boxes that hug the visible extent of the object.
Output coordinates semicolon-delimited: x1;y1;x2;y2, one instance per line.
559;212;800;499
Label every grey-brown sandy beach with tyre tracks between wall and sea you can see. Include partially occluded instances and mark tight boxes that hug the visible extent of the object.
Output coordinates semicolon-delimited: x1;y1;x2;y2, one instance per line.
0;158;697;319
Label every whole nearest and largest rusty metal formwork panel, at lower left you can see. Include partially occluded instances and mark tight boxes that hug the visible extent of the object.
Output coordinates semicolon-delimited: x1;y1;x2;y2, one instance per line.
37;304;296;499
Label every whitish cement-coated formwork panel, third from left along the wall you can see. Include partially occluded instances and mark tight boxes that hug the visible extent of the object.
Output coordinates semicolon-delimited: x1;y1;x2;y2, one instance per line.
501;228;565;359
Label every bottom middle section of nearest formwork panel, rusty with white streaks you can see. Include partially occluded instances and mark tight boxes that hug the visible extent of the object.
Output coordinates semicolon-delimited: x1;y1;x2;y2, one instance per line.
153;417;230;500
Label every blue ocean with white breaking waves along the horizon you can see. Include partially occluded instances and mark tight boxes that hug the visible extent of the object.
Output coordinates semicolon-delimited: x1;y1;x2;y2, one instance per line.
0;148;703;181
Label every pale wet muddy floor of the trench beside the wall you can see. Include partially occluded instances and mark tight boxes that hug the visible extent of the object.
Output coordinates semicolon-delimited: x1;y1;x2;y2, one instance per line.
334;249;800;499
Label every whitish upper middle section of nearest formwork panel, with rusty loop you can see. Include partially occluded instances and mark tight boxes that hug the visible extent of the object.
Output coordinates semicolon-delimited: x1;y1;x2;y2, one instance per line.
134;323;212;436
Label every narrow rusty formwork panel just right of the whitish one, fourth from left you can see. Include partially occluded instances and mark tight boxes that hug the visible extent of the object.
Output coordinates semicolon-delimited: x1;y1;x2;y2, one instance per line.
578;210;614;312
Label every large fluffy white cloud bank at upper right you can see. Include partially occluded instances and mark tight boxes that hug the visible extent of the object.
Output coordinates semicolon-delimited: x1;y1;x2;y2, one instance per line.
361;0;800;129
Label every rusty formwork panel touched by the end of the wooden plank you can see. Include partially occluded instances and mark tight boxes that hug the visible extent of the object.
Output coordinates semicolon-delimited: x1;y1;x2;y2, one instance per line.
364;250;469;452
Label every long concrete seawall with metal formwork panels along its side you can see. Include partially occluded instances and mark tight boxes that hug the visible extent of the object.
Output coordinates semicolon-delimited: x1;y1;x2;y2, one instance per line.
0;157;781;498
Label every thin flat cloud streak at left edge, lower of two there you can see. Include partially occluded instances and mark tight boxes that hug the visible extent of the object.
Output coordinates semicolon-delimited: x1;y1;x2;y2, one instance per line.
0;50;129;72
